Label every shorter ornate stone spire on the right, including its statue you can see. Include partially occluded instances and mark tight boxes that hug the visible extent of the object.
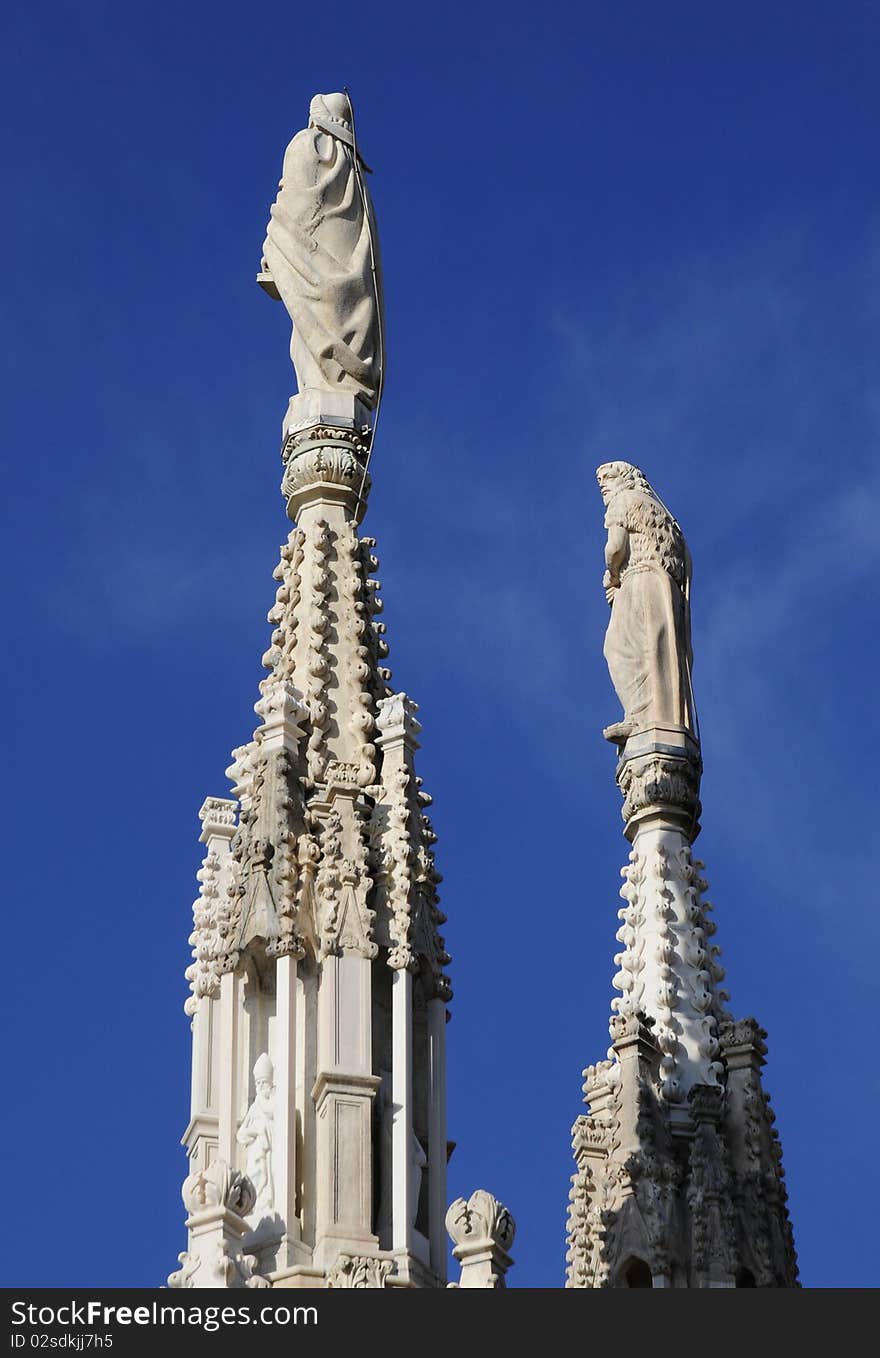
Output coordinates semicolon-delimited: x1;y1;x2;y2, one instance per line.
566;462;797;1287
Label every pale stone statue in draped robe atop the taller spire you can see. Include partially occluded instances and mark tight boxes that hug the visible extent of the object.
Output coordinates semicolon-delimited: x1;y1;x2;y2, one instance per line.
257;94;384;410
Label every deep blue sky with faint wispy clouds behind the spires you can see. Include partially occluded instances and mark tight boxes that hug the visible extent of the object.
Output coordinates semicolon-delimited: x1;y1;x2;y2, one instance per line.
0;0;880;1287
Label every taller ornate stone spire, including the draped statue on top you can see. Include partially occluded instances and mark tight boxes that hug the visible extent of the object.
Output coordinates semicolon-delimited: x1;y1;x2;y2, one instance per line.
170;96;451;1287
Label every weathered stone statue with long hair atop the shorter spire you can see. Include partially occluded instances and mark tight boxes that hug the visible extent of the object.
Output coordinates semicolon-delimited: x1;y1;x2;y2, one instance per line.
596;462;697;746
